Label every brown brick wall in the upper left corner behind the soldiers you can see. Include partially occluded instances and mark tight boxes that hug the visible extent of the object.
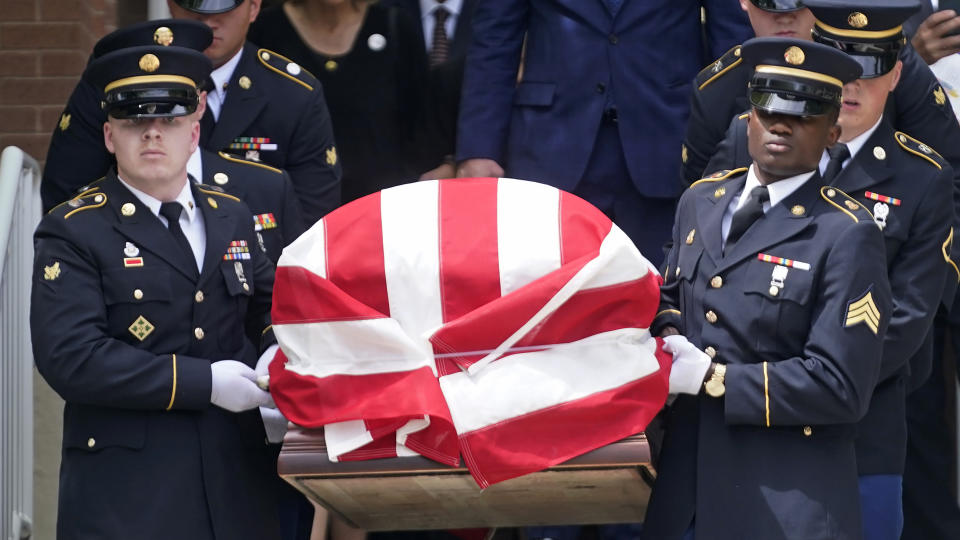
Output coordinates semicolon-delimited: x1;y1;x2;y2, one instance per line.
0;0;118;166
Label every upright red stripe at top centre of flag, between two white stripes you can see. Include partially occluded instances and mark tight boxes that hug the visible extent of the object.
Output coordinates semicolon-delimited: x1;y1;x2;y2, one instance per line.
440;180;500;323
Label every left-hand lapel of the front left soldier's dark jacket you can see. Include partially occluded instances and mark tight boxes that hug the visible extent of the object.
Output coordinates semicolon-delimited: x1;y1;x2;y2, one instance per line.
102;170;196;280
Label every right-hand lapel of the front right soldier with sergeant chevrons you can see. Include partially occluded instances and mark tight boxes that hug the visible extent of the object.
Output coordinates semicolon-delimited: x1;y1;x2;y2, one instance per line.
716;173;823;274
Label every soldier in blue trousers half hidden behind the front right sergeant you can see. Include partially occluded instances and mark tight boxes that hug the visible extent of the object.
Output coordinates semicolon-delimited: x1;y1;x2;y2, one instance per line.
710;10;960;539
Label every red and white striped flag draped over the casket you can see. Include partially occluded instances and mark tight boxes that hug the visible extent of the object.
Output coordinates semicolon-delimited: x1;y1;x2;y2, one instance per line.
270;178;669;487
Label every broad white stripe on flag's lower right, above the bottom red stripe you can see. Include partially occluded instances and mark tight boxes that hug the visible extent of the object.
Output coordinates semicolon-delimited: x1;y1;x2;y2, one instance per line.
440;328;660;436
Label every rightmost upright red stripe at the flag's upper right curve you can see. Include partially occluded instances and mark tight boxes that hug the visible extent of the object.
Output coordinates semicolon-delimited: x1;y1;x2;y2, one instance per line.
560;191;613;264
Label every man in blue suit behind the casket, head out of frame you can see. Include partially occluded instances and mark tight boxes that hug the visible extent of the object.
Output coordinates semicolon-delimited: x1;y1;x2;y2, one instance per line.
456;0;751;263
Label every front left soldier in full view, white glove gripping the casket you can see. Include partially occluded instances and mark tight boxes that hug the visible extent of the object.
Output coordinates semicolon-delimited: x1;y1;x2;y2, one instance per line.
30;40;279;540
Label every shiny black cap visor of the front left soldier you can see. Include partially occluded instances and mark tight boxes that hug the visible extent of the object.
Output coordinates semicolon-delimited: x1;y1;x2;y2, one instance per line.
103;87;199;119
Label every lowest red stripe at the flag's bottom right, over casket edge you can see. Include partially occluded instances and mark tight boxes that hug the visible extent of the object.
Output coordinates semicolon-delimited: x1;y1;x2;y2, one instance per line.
460;339;672;489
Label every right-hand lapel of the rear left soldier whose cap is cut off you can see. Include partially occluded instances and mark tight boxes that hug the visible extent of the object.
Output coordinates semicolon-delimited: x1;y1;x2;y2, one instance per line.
207;43;267;151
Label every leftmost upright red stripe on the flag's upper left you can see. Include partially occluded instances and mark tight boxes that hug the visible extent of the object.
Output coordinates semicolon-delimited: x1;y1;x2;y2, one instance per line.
323;192;390;316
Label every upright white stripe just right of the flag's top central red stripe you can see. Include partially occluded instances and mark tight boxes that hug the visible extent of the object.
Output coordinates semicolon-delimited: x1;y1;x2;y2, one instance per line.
497;178;561;296
